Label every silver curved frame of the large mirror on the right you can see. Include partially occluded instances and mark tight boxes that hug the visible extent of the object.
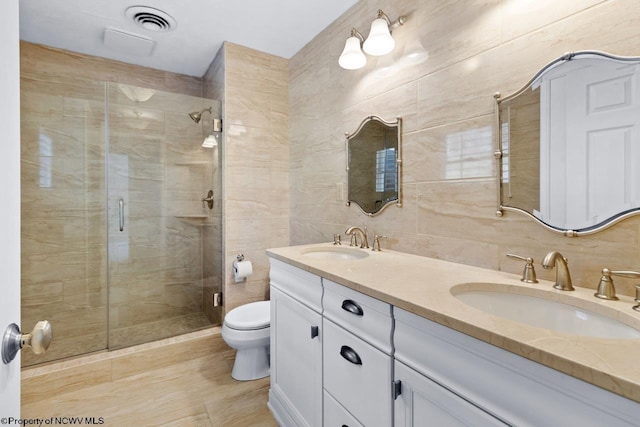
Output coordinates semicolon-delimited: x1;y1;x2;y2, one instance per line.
493;50;640;237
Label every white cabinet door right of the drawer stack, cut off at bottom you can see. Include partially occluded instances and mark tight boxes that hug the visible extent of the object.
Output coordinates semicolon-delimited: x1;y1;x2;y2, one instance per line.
394;361;506;427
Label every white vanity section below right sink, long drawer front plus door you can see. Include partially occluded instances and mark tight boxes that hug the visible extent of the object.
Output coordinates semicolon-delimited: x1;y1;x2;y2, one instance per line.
394;307;640;427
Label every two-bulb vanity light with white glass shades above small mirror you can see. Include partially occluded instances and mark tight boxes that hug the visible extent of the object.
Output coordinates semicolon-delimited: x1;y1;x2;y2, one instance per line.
338;9;407;70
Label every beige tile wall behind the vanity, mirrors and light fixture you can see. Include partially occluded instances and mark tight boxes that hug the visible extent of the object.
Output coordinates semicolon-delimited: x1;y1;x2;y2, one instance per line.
292;0;640;294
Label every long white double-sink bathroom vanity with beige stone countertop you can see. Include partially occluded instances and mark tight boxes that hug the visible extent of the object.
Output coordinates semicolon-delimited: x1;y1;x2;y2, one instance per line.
268;244;640;427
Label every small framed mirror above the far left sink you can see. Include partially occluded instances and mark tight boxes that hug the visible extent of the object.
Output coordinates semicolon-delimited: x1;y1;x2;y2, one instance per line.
345;116;402;216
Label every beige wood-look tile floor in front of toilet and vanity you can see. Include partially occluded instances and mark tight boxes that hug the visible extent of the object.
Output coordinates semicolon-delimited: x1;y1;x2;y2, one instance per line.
22;340;277;427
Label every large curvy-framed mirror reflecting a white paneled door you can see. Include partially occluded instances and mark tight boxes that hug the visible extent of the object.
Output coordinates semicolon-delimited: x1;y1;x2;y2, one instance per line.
494;51;640;237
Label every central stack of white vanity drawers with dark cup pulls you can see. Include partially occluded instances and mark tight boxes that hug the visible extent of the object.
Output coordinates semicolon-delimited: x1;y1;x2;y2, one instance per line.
322;279;393;427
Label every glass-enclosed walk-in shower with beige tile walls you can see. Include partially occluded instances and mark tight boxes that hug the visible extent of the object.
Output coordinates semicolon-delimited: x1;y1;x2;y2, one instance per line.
21;72;222;366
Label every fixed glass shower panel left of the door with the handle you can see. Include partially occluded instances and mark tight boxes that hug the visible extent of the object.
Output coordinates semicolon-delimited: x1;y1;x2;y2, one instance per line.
20;75;107;366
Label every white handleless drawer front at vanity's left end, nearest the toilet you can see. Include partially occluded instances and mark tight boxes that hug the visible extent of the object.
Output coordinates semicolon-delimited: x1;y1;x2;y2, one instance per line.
269;258;322;313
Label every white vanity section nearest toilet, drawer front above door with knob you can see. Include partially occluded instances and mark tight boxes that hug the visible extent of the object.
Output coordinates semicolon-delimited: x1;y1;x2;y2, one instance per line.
268;259;323;427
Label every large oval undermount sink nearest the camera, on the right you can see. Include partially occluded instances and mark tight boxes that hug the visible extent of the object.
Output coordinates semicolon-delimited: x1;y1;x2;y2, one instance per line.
451;283;640;339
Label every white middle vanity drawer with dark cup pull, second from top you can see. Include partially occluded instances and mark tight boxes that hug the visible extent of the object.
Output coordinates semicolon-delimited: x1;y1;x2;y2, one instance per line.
322;319;393;426
